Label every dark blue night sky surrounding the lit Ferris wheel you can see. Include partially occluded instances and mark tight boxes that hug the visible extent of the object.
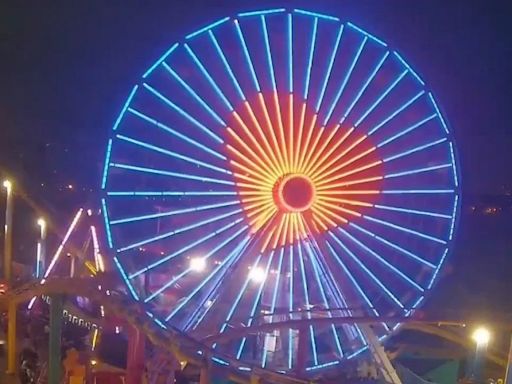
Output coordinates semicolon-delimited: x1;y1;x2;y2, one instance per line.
0;0;512;322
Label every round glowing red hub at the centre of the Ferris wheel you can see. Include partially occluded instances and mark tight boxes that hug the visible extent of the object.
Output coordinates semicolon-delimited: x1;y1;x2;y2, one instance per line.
274;175;315;212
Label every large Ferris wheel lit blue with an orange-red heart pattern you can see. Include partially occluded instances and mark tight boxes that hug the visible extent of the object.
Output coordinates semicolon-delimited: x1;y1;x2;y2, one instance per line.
102;9;460;372
